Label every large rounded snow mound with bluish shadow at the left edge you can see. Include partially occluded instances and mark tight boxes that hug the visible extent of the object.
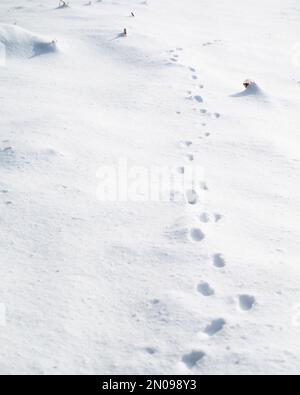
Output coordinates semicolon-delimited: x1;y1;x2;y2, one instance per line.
0;24;57;58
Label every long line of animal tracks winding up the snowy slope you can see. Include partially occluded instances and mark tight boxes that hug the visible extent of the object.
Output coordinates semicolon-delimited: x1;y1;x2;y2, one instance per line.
168;47;256;370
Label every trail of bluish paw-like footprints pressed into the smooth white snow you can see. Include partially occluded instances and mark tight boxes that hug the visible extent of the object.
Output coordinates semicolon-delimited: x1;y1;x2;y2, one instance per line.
165;44;256;369
